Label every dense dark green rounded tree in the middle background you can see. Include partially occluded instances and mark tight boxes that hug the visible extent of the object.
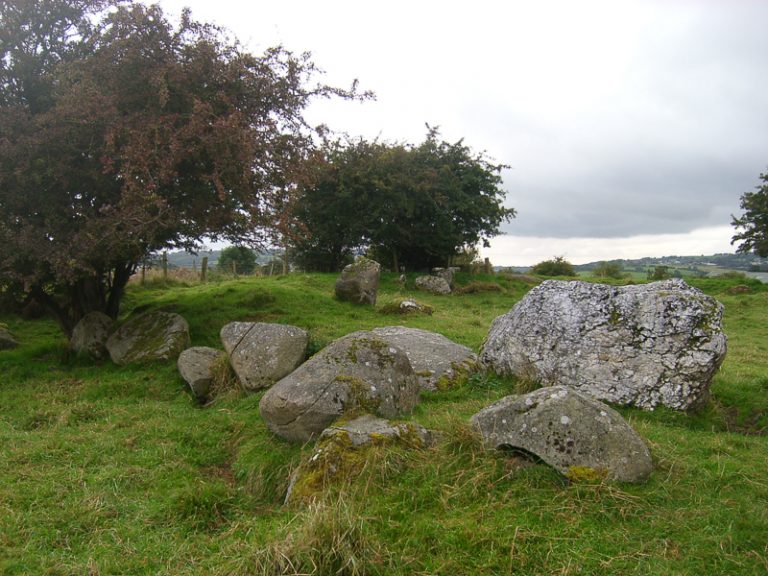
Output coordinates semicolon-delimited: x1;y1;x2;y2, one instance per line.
296;128;515;270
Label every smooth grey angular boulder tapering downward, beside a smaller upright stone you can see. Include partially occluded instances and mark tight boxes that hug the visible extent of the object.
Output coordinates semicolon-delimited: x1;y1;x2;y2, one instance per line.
221;322;309;392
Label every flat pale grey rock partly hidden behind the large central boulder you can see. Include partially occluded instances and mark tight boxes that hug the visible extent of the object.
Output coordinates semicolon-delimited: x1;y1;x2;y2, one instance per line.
372;326;477;391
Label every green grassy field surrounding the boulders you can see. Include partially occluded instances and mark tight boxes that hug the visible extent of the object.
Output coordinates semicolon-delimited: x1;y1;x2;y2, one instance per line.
0;274;768;576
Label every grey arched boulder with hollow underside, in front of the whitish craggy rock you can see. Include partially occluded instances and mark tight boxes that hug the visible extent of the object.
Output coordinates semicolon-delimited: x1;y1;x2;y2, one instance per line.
471;386;653;482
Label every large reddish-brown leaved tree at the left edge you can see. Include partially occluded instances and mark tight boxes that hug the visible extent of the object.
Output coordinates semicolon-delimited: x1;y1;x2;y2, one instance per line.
0;0;362;332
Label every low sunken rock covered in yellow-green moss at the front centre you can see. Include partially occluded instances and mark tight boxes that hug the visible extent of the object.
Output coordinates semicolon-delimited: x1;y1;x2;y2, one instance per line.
285;414;432;504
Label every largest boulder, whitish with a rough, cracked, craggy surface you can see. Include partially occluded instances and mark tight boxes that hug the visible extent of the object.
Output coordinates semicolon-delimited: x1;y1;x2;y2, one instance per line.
480;280;726;410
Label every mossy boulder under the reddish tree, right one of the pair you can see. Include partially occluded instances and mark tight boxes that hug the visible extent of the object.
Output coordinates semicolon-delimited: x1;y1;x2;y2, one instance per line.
107;312;189;365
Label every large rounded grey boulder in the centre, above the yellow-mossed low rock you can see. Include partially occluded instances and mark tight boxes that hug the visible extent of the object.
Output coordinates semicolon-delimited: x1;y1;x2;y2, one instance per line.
259;332;419;442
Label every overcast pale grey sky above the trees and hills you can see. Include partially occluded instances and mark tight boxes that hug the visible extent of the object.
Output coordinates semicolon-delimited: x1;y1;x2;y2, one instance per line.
160;0;768;265
